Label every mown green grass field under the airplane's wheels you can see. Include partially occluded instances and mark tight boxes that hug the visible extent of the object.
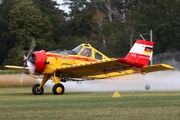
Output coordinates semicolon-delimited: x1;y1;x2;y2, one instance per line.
0;87;180;120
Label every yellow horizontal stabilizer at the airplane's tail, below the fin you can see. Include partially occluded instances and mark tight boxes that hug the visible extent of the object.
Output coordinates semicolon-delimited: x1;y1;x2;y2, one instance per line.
141;64;175;73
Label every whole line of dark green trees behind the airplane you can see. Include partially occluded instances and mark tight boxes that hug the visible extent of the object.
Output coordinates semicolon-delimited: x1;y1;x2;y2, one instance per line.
0;0;180;69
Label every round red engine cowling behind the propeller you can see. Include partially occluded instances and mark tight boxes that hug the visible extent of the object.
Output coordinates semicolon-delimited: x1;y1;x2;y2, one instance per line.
31;50;47;74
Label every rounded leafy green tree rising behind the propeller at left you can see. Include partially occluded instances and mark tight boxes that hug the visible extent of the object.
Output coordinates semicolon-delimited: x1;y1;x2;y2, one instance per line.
5;1;53;64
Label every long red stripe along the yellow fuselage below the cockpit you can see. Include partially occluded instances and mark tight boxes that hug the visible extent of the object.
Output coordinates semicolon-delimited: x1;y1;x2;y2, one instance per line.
47;53;97;62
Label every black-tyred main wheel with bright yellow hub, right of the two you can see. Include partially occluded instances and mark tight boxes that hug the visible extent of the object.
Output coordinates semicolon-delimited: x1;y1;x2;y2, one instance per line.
52;83;65;95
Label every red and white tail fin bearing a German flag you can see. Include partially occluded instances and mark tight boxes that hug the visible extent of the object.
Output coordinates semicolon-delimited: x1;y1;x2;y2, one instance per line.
125;40;154;66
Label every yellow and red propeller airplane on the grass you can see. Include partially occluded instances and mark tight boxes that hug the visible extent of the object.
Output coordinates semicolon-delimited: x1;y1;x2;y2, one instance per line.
5;39;174;95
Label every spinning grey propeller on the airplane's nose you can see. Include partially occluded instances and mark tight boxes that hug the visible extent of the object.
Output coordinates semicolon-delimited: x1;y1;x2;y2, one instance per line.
19;39;36;83
